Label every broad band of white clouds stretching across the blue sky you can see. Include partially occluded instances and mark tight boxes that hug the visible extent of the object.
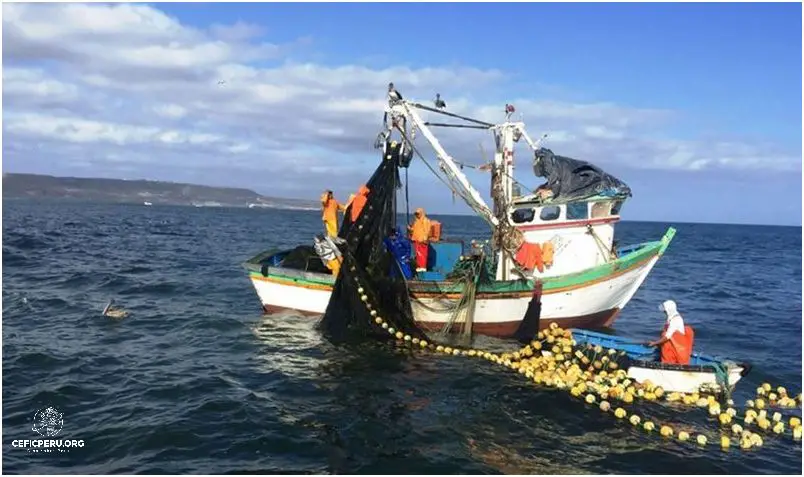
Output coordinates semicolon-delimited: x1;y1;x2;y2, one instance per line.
3;4;801;203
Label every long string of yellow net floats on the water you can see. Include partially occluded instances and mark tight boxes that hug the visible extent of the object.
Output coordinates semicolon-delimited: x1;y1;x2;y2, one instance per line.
358;287;802;450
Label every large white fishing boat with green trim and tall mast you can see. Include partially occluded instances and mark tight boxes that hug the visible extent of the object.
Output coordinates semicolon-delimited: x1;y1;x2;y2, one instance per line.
244;86;675;337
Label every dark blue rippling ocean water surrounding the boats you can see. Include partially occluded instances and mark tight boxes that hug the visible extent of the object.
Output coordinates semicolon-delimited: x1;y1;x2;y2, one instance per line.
2;201;802;474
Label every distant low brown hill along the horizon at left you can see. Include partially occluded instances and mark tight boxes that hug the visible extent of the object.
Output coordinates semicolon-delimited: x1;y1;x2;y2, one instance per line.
3;173;320;210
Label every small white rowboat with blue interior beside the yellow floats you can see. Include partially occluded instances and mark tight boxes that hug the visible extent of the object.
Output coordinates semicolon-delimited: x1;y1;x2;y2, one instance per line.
571;329;751;394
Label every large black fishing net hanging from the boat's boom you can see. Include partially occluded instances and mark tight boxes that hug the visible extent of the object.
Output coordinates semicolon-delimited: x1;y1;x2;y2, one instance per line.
318;145;426;341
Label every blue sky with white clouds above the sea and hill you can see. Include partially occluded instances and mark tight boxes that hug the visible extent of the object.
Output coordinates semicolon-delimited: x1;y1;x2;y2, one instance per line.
2;3;802;225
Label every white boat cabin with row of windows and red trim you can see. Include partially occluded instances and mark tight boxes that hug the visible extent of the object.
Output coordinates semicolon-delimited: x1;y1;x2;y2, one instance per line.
508;196;625;277
